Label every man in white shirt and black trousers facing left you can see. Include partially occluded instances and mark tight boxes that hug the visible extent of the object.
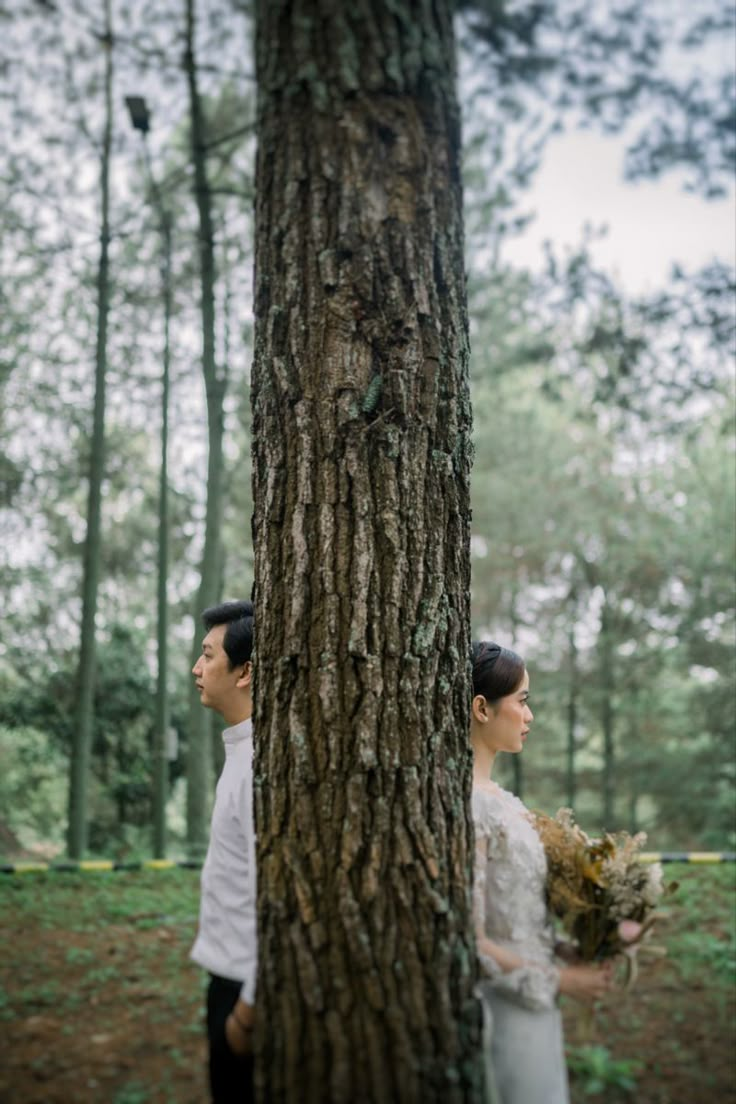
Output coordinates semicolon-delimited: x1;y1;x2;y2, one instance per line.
191;602;257;1104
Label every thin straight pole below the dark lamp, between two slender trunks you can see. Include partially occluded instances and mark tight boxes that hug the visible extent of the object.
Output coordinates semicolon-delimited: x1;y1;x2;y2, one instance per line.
153;210;171;859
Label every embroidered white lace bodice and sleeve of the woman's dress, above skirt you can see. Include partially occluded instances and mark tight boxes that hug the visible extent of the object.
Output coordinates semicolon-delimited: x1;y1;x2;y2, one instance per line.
472;786;559;1008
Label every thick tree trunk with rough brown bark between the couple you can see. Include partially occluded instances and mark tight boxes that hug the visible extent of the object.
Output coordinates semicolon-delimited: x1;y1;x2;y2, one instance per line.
253;0;480;1104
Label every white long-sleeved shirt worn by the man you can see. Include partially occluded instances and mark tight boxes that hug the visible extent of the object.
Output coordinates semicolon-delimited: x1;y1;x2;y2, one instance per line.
191;720;258;1005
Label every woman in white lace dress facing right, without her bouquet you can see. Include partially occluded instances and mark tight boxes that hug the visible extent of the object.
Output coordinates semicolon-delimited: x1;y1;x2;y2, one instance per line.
470;643;611;1104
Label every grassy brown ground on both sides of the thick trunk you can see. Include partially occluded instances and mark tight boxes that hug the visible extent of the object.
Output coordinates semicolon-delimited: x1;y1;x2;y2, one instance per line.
0;866;736;1104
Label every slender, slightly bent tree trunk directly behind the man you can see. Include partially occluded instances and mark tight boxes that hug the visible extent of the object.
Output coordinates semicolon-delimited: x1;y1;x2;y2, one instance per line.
184;0;226;854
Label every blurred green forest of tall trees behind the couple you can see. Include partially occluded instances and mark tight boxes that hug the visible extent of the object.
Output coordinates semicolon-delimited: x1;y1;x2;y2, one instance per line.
0;0;736;858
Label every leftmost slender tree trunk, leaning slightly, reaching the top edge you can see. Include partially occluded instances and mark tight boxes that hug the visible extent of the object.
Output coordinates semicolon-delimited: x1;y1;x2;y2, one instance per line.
67;0;113;859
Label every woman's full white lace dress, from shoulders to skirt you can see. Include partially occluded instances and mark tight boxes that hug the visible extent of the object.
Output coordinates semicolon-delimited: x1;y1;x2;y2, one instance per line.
472;787;569;1104
